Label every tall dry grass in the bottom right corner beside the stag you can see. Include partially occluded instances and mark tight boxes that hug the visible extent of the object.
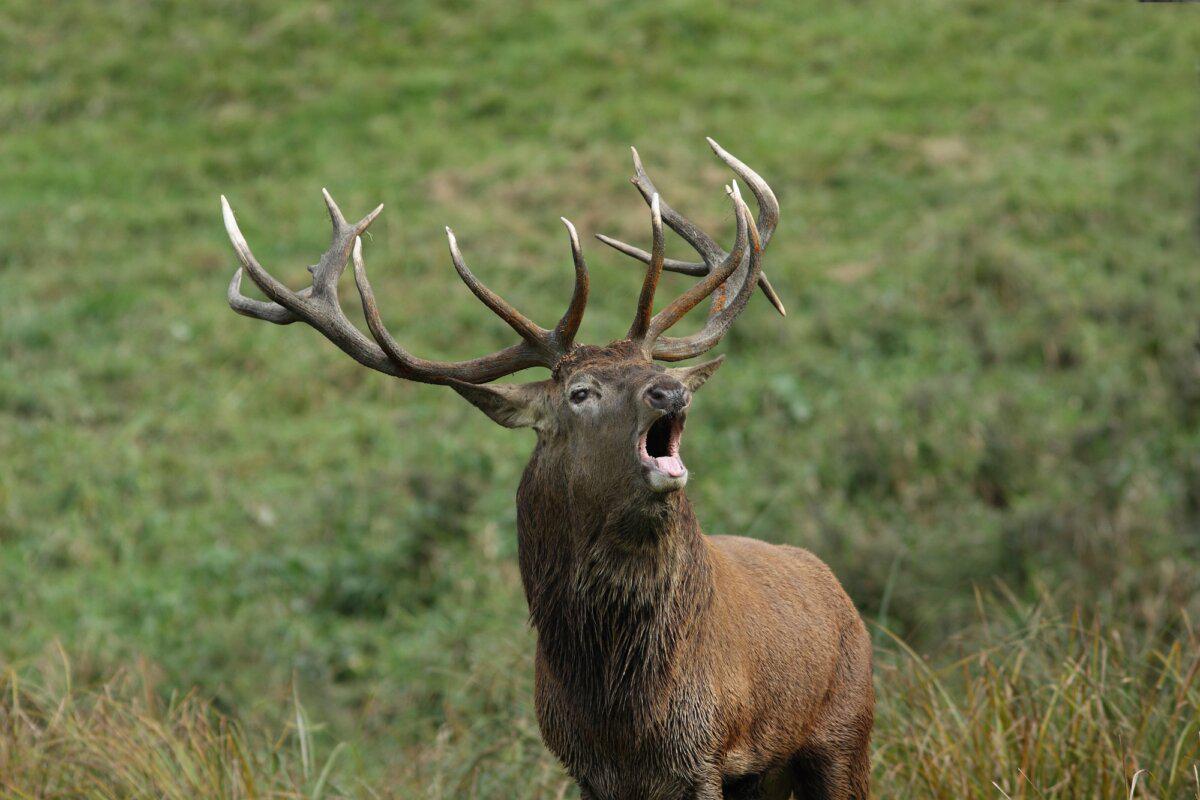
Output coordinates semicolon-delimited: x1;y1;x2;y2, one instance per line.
876;602;1200;800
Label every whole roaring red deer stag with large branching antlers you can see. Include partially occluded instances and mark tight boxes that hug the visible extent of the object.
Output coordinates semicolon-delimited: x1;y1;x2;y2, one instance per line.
222;140;875;800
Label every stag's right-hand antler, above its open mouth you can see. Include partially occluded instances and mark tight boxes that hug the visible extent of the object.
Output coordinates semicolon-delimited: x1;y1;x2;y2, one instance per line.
598;139;784;361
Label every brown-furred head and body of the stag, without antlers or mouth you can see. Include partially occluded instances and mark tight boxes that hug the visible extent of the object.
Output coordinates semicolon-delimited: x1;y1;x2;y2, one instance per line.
456;343;874;800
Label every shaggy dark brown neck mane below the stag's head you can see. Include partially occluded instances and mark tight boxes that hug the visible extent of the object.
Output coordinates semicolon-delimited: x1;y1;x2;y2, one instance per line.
517;452;712;716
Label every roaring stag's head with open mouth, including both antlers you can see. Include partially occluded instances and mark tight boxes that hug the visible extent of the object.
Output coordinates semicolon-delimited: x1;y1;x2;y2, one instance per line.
221;139;784;498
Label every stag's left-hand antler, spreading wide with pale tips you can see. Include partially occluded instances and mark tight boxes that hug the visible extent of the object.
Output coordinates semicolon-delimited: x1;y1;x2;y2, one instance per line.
221;190;588;384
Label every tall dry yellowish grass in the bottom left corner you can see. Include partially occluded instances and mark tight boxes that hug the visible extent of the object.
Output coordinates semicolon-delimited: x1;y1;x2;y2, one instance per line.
0;661;346;800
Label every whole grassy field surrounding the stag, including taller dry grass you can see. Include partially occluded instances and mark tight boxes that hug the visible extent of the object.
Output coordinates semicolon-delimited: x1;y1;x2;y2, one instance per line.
0;0;1200;799
